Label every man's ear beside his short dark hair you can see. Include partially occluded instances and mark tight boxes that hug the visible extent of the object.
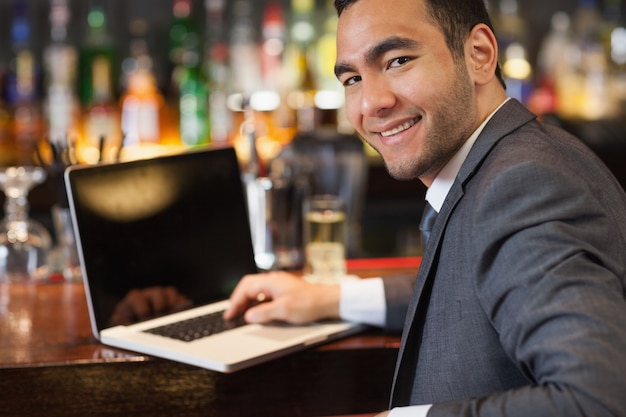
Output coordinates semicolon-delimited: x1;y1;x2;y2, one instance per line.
465;23;498;85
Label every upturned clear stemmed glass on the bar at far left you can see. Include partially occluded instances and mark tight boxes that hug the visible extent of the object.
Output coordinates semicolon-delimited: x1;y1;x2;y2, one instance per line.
0;166;51;282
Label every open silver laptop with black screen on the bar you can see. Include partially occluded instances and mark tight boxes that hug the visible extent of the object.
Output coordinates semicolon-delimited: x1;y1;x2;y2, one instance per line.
65;148;363;373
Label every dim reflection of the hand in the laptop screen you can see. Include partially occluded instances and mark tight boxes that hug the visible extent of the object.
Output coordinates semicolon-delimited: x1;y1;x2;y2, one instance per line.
109;287;191;325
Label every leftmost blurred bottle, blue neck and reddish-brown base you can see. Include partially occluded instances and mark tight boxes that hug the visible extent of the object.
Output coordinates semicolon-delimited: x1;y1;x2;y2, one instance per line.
4;0;42;165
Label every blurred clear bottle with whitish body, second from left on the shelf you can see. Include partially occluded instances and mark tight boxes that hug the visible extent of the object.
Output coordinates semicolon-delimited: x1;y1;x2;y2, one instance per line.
44;0;79;151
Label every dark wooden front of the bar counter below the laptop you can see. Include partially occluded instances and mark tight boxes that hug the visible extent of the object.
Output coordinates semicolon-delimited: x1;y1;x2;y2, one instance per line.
0;348;396;417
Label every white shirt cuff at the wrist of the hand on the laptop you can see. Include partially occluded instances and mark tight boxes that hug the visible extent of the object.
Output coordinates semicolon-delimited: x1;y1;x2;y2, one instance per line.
339;278;386;327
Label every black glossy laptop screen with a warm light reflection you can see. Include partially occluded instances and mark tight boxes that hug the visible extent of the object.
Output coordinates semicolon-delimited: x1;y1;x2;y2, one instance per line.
66;148;257;330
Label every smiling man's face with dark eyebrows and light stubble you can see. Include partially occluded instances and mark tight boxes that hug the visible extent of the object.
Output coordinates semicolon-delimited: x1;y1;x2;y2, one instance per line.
336;0;477;185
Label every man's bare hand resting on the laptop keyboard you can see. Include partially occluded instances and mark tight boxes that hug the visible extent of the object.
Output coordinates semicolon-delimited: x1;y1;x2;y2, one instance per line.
224;271;340;324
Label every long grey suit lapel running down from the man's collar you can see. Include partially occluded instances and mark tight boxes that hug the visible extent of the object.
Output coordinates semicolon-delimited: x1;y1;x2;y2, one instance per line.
390;100;535;407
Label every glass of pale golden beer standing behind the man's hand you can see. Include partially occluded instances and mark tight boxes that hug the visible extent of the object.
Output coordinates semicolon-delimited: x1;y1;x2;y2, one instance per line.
302;194;346;284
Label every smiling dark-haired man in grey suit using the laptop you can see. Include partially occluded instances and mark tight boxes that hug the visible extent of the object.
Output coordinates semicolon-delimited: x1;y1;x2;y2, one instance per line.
226;0;626;417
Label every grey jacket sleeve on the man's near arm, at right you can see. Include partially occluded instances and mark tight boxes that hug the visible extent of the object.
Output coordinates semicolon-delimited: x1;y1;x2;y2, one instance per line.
428;149;626;417
